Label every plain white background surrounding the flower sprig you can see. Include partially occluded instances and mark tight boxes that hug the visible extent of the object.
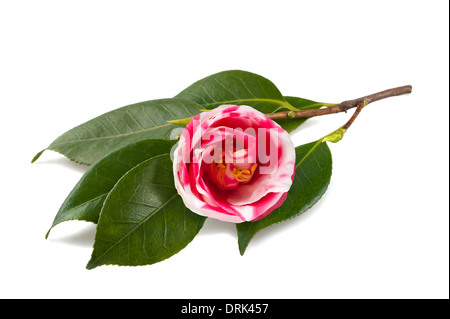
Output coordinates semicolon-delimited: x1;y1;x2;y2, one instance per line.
0;0;449;298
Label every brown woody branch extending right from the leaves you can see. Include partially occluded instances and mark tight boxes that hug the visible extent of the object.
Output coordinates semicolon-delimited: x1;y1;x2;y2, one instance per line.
266;85;412;120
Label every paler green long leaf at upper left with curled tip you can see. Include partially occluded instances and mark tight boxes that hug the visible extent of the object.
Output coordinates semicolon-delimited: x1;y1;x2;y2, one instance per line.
32;99;201;165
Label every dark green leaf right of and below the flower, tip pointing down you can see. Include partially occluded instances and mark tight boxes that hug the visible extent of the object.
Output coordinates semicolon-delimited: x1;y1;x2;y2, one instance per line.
236;139;332;255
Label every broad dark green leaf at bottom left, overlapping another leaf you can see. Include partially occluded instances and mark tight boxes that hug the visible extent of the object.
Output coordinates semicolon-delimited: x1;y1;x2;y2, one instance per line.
87;155;206;269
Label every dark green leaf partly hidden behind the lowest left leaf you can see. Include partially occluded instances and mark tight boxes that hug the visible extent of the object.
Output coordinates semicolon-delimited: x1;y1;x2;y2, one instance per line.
46;140;175;238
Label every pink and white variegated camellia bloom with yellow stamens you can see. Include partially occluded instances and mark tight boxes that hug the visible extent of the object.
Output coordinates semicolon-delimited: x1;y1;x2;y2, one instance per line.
173;105;295;223
